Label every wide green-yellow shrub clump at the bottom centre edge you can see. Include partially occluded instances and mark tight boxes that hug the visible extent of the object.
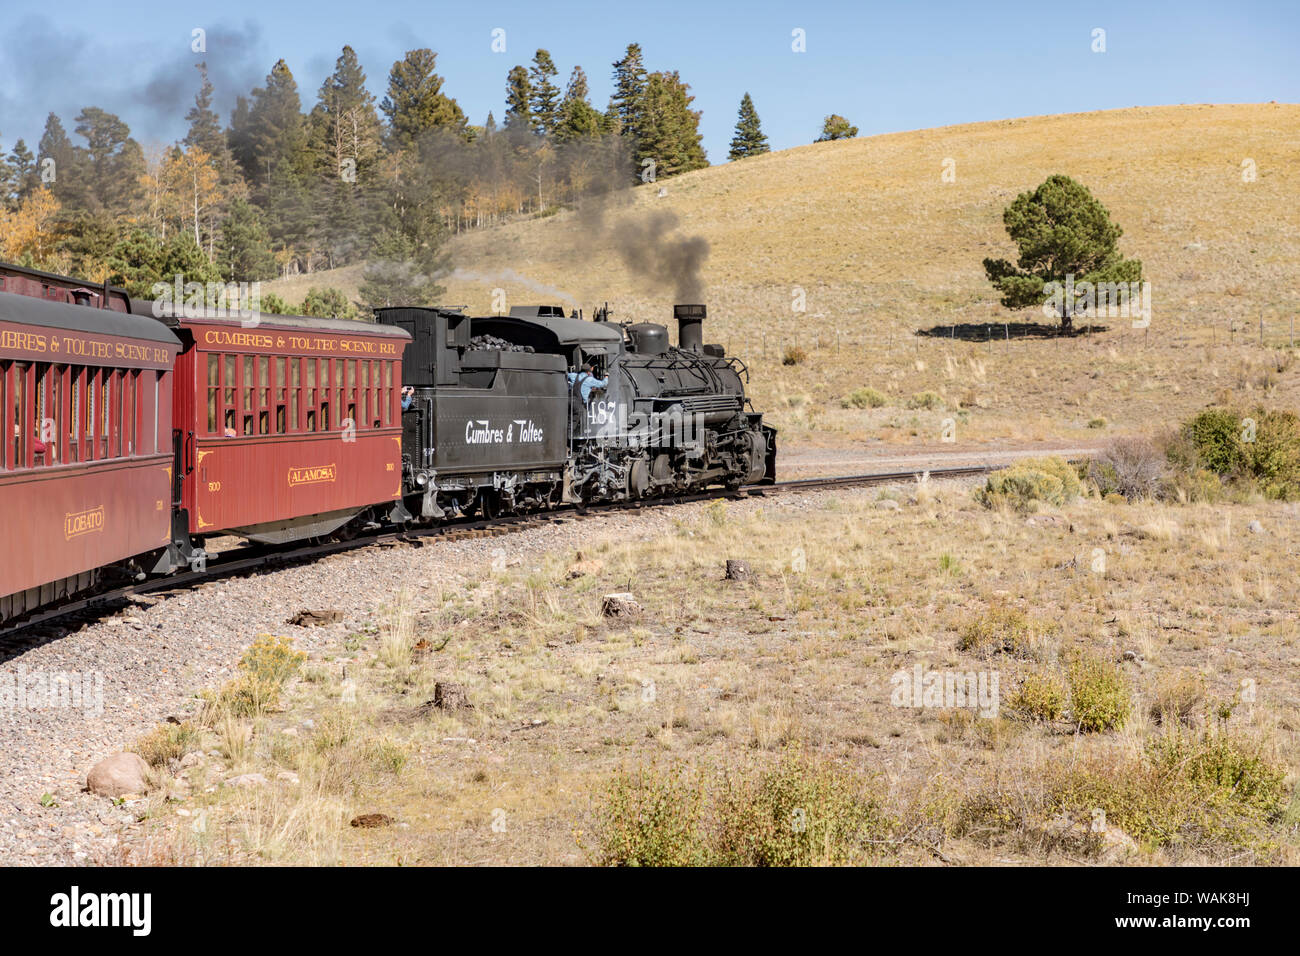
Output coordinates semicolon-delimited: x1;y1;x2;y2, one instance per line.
594;747;893;866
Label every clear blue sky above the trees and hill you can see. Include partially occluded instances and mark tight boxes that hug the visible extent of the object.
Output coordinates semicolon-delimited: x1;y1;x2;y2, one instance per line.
0;0;1300;163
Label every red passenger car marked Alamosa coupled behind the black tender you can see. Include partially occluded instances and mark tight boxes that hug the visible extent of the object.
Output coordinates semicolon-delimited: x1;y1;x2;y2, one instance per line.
161;314;410;548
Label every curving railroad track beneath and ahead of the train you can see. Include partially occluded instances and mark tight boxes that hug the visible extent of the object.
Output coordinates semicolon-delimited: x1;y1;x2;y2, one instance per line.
0;464;1005;642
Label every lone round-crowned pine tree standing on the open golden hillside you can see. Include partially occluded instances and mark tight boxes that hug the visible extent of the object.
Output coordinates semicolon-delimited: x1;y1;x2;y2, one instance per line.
984;174;1141;332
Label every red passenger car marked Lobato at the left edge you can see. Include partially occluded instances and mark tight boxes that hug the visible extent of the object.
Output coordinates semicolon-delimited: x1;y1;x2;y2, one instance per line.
0;287;179;620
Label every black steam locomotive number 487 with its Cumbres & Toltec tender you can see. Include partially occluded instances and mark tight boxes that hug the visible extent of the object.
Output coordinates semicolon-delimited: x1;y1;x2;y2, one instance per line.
378;304;776;520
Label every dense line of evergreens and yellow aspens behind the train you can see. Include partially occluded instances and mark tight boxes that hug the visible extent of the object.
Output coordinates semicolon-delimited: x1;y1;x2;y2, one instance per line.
0;43;738;304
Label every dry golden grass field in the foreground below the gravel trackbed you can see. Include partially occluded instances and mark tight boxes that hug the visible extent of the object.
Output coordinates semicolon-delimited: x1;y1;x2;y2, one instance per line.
122;485;1300;864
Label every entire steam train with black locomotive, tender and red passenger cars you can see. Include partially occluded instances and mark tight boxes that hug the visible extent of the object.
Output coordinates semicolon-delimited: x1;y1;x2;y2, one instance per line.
0;263;776;623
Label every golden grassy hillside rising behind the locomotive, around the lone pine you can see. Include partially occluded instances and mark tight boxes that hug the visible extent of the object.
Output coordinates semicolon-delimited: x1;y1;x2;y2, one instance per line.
266;103;1300;444
